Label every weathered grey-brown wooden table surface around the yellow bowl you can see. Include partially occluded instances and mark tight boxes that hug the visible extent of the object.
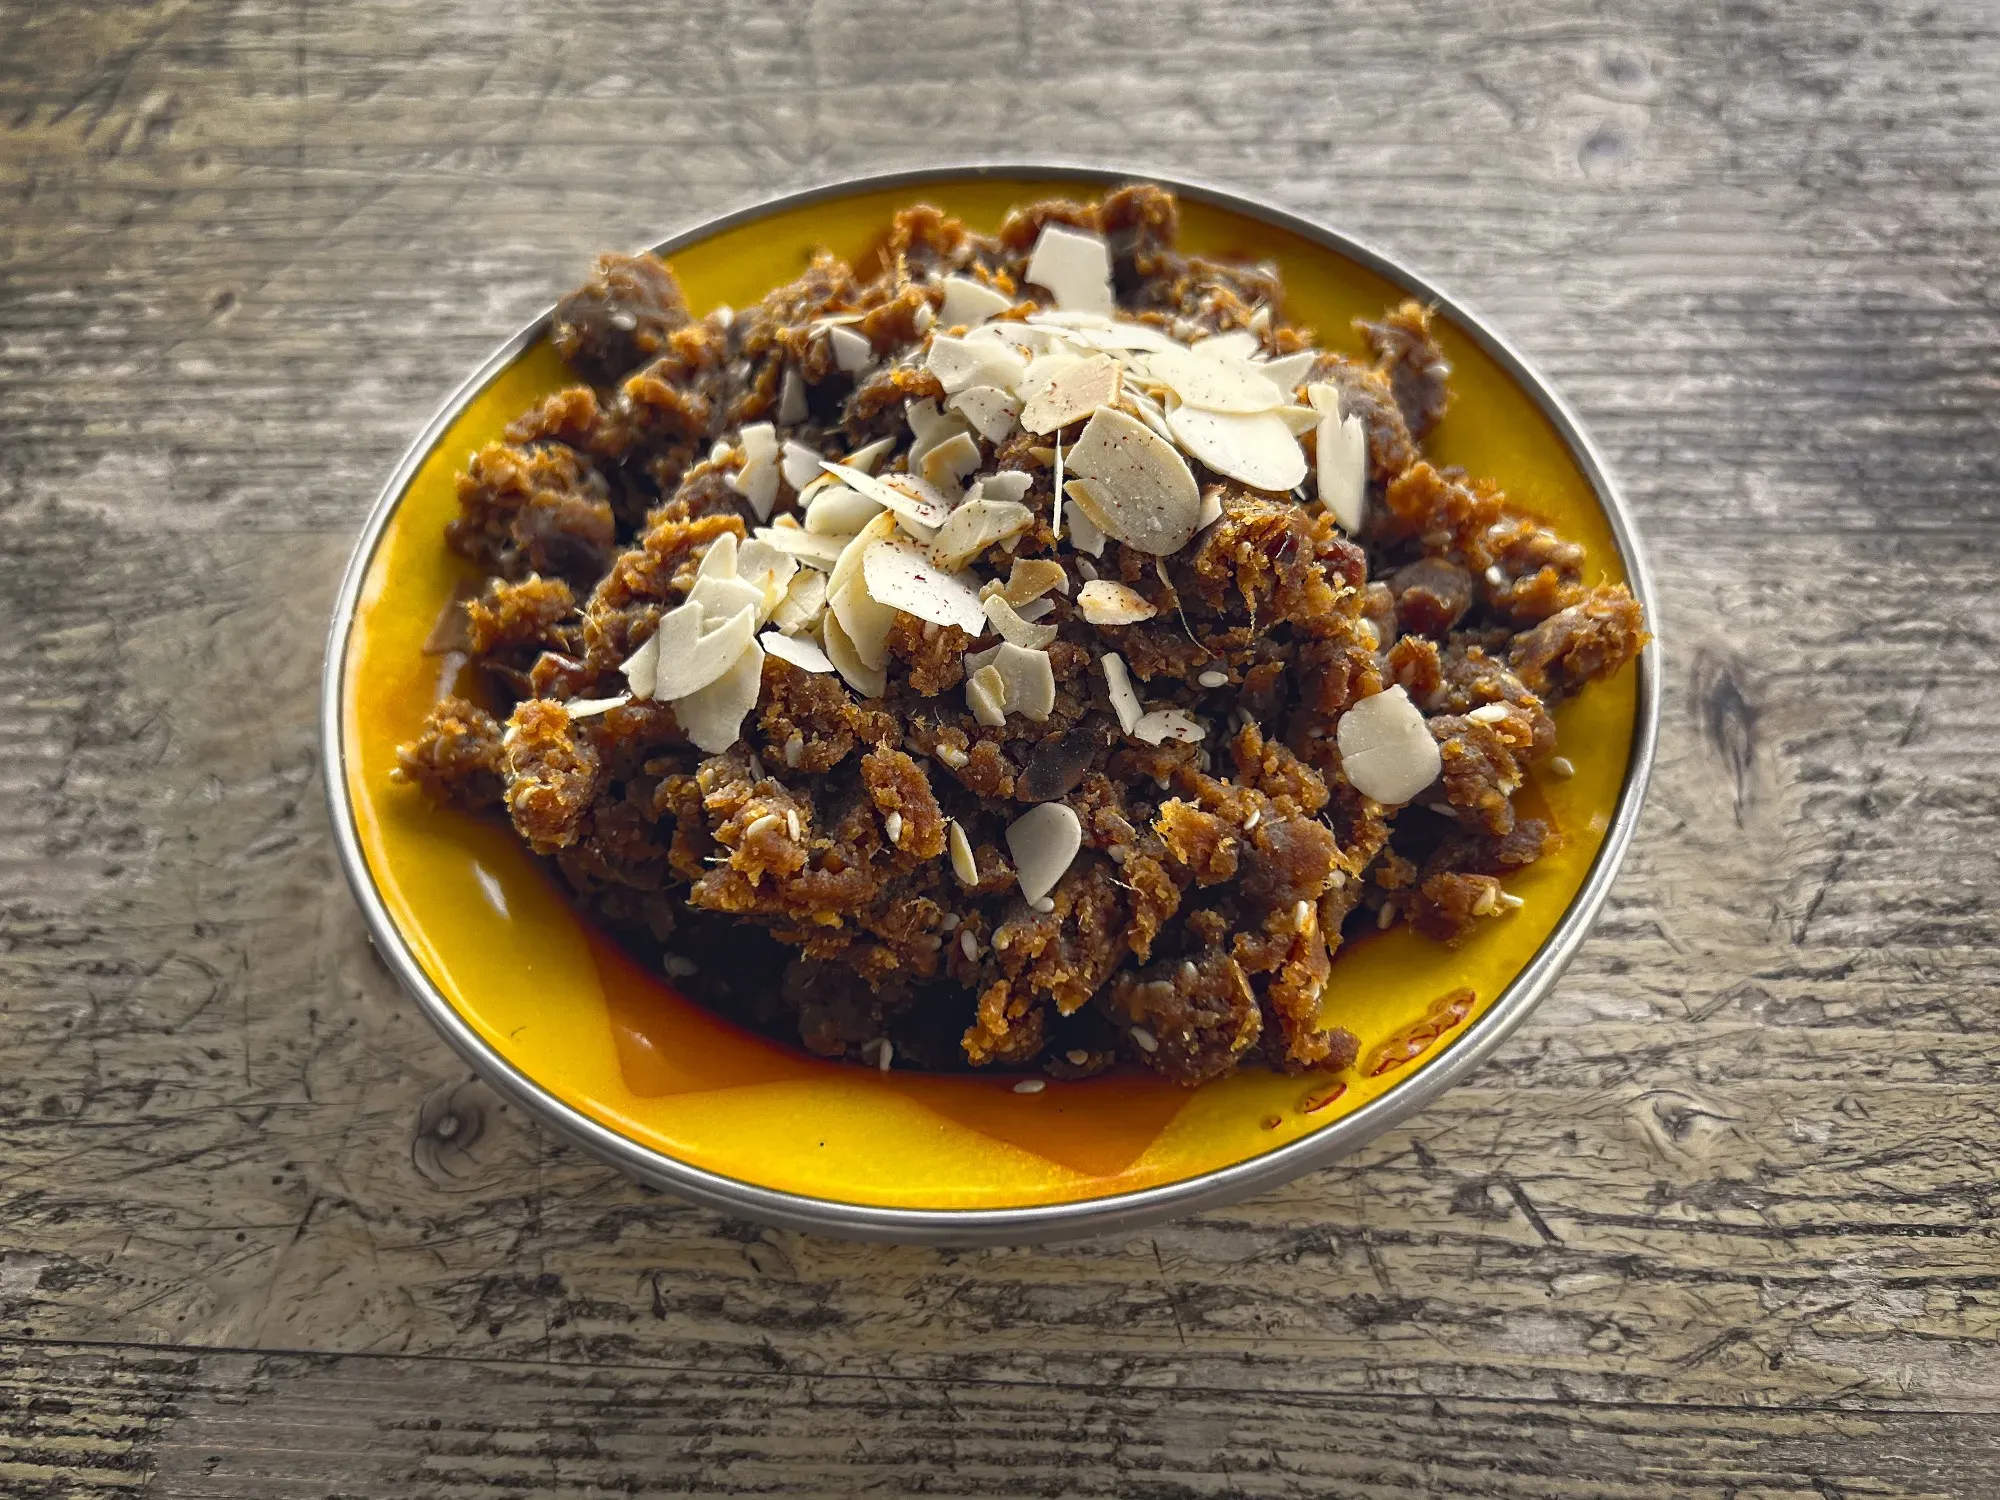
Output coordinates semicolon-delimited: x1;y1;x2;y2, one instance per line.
0;0;2000;1500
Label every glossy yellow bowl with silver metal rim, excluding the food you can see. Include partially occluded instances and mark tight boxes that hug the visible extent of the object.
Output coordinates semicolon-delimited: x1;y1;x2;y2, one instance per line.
322;168;1660;1242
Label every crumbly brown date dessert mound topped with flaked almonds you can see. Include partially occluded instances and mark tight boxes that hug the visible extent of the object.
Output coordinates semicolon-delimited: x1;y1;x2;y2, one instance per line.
394;186;1646;1084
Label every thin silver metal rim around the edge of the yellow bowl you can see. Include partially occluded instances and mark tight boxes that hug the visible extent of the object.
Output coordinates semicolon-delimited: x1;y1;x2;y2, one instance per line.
320;162;1662;1244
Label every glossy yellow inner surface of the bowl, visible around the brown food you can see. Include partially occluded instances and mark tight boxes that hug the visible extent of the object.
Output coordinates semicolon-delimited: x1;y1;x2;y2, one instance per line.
342;178;1636;1210
